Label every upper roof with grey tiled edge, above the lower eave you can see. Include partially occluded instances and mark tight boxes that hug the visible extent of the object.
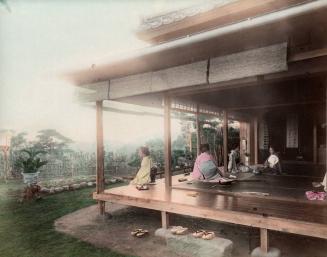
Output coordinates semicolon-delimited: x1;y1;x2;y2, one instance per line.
137;0;309;43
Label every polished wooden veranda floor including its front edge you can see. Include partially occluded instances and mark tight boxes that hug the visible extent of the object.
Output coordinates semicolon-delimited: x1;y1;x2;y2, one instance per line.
94;175;327;239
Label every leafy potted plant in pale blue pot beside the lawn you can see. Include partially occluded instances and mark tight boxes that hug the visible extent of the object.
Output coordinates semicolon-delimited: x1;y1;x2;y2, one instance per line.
17;148;48;185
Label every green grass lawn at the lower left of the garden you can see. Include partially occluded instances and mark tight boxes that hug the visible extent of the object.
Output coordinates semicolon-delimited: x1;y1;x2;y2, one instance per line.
0;182;135;257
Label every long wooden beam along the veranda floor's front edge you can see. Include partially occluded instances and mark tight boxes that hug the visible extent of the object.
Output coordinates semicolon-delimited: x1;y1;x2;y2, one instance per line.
93;189;327;239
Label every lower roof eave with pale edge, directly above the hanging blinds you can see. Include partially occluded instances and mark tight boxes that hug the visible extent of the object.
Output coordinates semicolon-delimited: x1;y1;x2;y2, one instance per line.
66;0;327;85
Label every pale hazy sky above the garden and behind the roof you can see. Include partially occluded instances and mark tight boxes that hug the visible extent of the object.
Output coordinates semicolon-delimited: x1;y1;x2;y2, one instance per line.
0;0;196;147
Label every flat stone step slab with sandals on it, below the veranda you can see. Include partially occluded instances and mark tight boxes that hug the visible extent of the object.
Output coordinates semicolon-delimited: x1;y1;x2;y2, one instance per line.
155;228;233;257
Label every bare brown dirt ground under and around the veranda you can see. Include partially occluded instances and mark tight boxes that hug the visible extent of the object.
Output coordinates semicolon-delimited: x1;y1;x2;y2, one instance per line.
55;203;327;257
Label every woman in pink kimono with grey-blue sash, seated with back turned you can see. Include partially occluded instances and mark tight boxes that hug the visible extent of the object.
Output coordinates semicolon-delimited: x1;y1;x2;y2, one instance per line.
192;144;221;181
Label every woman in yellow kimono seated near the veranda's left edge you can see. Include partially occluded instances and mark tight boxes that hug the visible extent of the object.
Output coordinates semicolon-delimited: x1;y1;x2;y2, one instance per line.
130;146;152;185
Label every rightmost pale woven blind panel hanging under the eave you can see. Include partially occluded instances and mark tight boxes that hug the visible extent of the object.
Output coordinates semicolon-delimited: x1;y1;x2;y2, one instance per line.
209;43;287;83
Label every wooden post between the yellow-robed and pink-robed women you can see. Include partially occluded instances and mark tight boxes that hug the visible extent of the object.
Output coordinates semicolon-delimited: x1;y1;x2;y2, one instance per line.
164;95;172;191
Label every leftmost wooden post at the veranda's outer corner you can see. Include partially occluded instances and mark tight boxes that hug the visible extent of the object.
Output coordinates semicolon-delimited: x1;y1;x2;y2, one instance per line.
96;101;105;215
